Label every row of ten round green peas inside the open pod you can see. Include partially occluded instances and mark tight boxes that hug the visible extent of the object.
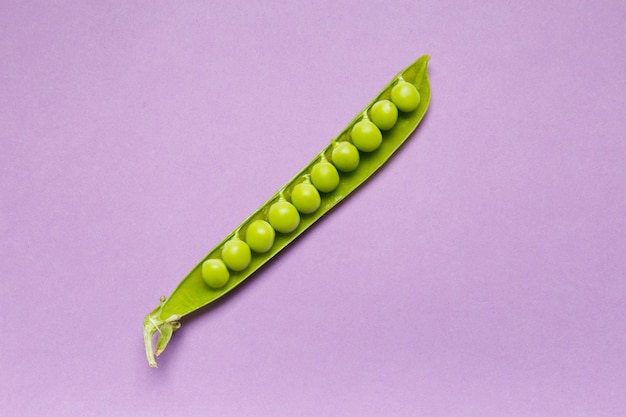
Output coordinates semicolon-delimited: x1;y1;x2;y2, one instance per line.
202;80;420;289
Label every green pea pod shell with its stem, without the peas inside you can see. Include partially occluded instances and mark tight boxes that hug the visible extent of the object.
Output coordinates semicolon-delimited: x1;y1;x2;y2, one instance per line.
143;55;430;367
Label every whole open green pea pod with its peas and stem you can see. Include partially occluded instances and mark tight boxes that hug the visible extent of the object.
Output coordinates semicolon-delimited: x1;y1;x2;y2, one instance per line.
143;55;430;367
